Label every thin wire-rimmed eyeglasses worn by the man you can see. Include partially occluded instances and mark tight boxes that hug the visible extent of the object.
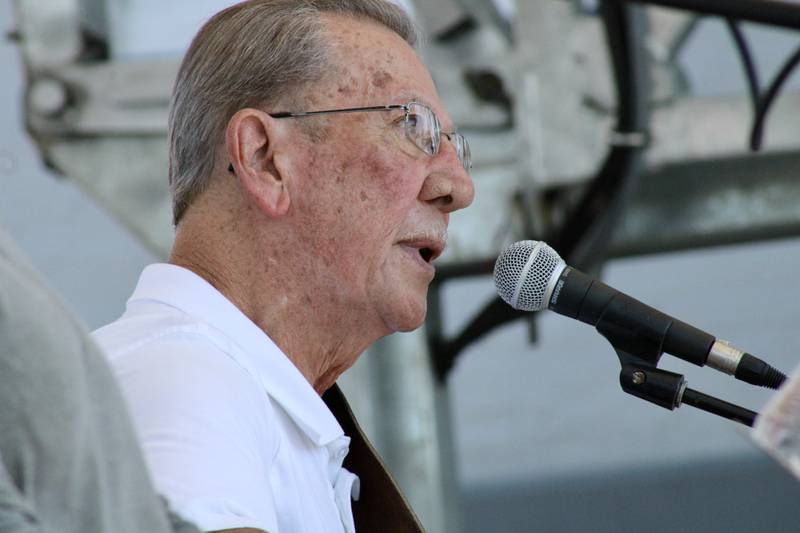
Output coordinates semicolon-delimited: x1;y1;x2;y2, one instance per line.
269;102;472;171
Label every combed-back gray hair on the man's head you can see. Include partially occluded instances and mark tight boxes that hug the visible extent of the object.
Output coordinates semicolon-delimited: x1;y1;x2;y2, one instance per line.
169;0;417;225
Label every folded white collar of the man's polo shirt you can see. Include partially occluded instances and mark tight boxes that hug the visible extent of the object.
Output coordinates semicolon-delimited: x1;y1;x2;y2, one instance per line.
128;263;344;447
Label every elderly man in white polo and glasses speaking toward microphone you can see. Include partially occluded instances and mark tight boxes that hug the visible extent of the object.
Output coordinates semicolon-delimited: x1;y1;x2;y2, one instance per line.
96;0;473;532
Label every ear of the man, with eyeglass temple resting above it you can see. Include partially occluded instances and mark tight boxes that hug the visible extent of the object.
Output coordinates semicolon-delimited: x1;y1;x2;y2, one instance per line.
225;108;291;218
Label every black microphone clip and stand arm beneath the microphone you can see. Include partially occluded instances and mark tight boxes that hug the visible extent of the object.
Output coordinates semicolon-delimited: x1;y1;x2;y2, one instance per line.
595;317;758;427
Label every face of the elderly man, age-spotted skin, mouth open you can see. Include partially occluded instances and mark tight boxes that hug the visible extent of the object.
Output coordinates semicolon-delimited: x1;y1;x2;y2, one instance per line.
290;17;474;334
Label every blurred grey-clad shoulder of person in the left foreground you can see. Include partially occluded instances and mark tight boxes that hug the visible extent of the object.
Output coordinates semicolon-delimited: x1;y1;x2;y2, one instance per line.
0;225;196;533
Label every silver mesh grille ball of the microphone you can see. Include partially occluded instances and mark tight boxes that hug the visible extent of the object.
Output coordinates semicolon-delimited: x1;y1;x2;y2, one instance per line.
494;241;566;311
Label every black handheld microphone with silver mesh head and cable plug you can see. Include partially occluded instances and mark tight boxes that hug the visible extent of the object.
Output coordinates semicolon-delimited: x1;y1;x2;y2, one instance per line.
494;241;786;389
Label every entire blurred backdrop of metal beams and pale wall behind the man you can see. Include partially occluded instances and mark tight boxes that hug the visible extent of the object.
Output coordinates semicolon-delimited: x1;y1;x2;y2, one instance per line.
0;0;800;532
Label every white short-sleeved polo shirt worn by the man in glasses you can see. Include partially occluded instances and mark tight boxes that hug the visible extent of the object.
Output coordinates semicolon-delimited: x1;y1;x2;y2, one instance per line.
94;264;358;533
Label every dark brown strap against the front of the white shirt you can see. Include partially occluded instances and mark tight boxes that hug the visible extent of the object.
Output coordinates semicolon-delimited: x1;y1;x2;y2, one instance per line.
322;385;425;533
